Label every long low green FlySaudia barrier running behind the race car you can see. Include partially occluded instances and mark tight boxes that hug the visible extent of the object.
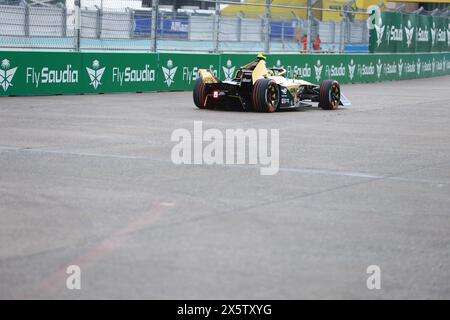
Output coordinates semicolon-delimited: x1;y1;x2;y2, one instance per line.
0;51;450;96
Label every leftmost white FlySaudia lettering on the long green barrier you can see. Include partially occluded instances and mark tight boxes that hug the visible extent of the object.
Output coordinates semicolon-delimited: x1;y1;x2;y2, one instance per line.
26;64;78;88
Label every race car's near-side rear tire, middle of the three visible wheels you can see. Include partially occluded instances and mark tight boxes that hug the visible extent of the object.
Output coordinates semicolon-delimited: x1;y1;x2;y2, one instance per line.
251;79;280;112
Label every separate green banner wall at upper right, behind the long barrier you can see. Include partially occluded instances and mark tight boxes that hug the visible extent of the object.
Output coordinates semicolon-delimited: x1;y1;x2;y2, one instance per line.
369;12;450;53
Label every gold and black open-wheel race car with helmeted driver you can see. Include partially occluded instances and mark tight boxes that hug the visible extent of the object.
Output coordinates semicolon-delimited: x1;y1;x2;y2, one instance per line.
193;55;350;112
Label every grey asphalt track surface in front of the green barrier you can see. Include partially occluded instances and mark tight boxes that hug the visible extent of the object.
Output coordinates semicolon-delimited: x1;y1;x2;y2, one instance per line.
0;77;450;299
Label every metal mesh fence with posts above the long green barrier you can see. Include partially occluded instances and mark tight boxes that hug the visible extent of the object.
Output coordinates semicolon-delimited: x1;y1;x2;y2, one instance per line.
0;0;432;52
